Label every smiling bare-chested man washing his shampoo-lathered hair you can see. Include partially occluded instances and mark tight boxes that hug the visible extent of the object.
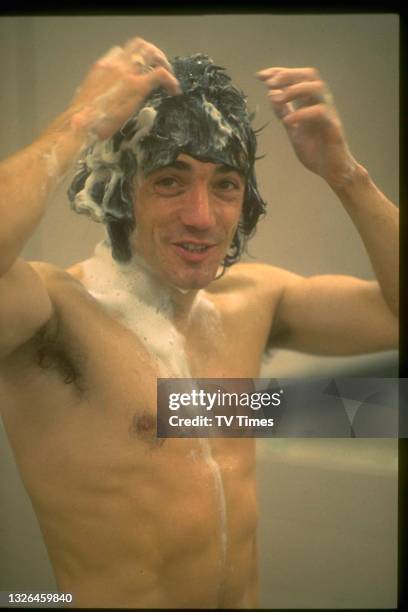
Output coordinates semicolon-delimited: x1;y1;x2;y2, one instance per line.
0;39;398;608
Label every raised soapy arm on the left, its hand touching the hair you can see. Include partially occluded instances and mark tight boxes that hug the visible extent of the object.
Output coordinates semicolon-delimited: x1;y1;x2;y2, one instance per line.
0;38;179;356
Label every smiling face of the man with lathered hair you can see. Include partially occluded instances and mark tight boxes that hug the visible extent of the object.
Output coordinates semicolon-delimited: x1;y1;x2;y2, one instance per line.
132;154;245;289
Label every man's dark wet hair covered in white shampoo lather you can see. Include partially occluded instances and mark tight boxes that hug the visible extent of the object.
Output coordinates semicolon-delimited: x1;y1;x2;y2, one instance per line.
68;54;266;267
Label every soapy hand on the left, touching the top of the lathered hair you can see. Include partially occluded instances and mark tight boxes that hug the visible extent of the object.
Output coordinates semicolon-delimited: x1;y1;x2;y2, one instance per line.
70;38;181;140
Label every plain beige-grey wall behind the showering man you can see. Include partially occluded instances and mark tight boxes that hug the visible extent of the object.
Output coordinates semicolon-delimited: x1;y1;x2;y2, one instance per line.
0;14;399;609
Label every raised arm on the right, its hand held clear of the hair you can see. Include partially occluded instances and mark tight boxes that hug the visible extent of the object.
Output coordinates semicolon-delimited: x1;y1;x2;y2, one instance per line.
258;68;399;354
